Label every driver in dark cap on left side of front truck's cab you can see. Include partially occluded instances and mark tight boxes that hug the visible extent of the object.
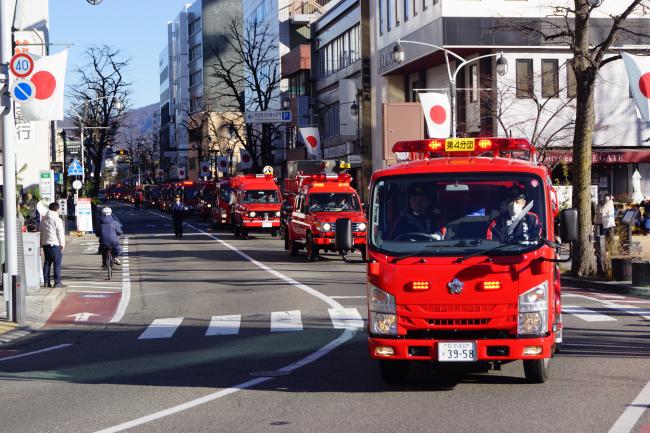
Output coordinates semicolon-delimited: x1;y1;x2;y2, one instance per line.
392;184;445;241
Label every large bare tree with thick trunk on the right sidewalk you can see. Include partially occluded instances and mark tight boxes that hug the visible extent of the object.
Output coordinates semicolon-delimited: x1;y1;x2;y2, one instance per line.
504;0;650;276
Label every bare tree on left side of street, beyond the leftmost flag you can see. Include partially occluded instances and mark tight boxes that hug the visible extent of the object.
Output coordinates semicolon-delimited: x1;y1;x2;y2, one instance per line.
70;45;130;196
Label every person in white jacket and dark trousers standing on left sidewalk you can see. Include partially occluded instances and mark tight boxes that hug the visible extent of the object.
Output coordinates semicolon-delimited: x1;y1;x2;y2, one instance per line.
40;202;65;288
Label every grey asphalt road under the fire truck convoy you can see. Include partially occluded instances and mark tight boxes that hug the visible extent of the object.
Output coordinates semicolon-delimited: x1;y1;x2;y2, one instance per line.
0;205;650;433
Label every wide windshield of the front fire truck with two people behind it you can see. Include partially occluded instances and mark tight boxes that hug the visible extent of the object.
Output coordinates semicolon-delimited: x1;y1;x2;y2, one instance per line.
370;173;546;256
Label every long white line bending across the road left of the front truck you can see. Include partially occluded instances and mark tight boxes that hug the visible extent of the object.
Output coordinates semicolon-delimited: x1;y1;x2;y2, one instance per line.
92;214;356;433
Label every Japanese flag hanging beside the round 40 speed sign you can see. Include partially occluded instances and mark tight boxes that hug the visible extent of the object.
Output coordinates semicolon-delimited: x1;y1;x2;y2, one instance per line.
20;50;68;121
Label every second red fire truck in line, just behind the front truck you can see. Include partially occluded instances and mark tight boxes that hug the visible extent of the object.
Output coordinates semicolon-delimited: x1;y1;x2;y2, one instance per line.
284;173;368;262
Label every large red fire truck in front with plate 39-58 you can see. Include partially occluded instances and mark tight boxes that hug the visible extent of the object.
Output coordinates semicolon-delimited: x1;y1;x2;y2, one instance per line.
367;138;577;383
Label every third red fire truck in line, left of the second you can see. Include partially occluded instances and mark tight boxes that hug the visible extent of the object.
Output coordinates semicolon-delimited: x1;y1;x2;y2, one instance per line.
232;174;280;239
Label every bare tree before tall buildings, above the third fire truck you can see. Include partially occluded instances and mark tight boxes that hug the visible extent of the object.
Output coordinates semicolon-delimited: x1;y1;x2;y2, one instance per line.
210;18;282;170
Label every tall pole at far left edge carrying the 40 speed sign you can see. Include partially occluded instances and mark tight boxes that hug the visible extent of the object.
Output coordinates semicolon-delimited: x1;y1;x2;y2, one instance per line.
0;0;22;322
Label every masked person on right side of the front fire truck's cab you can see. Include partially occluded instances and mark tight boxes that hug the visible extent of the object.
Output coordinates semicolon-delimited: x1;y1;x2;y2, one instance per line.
487;188;541;243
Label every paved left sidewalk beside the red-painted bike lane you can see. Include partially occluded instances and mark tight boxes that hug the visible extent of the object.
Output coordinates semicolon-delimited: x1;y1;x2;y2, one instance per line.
0;232;101;346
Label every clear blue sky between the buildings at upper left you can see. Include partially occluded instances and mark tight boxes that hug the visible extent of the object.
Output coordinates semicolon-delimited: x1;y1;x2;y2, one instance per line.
49;0;186;108
